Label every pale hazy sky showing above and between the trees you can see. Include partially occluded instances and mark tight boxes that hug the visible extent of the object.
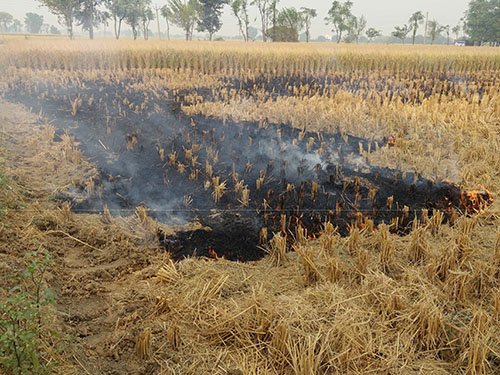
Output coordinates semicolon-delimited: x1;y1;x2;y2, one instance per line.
0;0;469;38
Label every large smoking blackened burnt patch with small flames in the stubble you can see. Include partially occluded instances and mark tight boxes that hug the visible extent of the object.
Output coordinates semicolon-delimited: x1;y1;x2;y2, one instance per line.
7;78;490;261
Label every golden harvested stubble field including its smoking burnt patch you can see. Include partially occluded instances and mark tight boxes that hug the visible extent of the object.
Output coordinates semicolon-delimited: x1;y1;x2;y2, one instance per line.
0;37;500;375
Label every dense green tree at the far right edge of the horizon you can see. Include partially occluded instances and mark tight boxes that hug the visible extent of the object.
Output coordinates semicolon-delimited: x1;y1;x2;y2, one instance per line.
465;0;500;43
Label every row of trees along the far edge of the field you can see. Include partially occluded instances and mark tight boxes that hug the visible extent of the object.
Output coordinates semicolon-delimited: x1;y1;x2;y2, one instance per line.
0;0;500;44
